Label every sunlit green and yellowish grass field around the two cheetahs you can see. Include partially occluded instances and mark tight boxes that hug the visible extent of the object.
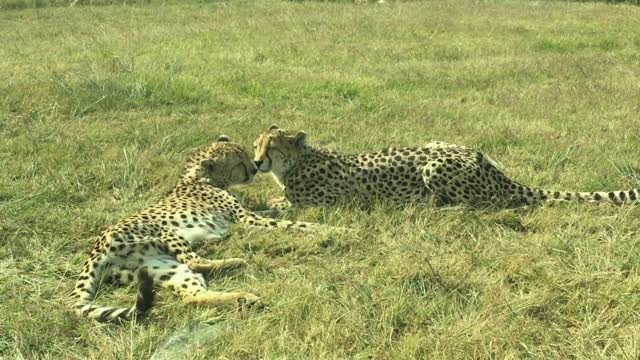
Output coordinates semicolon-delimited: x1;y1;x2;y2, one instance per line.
0;0;640;360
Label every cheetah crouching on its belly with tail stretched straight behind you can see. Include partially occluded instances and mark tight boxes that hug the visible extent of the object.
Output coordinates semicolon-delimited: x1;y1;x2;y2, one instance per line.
254;125;638;210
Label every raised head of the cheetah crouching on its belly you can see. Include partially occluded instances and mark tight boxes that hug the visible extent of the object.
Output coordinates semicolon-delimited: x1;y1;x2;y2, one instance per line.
253;125;307;175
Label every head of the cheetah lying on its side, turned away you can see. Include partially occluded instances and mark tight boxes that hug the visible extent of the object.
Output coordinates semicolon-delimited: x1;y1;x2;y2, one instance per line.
183;135;258;189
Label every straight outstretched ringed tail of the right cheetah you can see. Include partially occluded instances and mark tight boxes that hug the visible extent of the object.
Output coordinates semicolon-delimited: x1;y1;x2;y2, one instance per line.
522;188;640;205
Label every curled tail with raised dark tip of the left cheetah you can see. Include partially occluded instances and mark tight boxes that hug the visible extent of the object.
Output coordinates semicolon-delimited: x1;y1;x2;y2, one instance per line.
75;268;155;321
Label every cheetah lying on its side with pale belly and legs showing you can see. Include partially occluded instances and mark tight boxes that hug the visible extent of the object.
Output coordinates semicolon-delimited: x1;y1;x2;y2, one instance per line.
72;135;315;321
